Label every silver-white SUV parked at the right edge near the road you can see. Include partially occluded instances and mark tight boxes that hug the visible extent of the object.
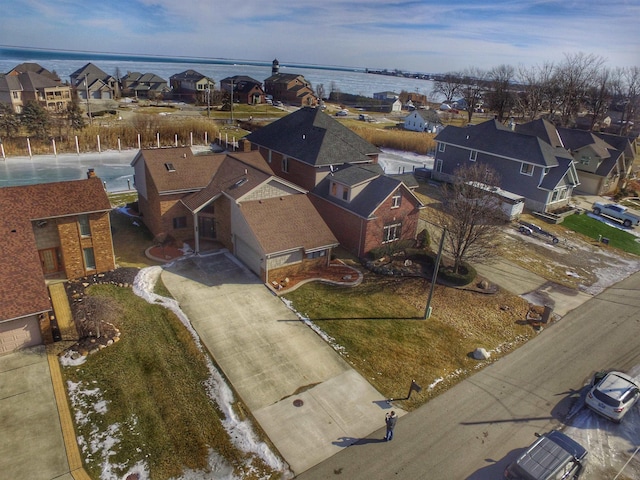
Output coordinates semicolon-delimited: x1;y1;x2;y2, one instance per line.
585;371;640;423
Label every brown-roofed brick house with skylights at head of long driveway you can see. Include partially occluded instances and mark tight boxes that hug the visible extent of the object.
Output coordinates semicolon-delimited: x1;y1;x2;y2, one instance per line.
132;147;338;282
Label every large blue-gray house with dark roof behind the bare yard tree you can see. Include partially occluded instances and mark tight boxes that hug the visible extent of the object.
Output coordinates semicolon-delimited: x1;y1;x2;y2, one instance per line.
433;120;580;212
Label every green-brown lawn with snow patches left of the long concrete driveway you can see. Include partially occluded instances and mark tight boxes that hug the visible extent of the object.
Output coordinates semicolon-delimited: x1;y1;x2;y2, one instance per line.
64;285;279;480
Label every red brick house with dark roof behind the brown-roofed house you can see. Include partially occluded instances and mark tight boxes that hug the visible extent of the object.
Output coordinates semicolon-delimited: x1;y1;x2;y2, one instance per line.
243;107;423;256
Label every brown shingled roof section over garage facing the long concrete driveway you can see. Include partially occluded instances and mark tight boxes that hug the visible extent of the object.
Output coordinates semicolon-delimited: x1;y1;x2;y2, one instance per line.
240;195;339;255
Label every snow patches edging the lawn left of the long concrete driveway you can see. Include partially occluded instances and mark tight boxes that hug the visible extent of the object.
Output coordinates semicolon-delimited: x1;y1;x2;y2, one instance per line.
61;266;291;480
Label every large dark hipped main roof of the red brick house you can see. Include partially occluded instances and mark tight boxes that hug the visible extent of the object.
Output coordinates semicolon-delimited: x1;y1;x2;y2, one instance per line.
245;107;379;166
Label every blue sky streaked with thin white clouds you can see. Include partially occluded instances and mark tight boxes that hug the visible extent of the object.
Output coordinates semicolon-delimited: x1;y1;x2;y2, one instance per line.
0;0;640;73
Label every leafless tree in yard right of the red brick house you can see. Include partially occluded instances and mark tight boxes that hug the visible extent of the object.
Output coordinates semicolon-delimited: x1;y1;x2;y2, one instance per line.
439;162;505;273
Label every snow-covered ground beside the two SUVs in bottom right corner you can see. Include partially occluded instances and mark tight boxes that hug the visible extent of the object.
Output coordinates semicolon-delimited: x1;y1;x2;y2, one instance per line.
565;365;640;479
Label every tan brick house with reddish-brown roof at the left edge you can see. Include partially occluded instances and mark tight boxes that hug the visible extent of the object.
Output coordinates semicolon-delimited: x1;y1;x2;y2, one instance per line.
0;177;115;355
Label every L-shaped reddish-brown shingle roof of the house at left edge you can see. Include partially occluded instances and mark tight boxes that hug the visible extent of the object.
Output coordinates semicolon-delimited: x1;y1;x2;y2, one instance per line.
0;177;111;320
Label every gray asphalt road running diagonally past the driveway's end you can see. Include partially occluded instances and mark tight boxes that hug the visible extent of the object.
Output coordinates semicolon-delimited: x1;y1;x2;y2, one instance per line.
297;273;640;480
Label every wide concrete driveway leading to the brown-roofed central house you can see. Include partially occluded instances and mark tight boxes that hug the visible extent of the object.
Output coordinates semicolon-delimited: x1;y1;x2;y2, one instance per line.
162;253;404;474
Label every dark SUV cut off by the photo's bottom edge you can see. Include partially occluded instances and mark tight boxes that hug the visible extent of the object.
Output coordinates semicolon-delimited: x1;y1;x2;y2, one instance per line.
504;430;588;480
